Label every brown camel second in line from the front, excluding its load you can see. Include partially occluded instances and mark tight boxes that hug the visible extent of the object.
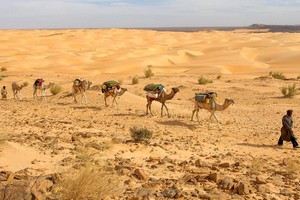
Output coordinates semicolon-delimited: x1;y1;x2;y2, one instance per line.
146;88;179;117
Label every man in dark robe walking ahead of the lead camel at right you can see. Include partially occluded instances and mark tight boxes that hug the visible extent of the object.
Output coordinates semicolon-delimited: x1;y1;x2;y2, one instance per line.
278;110;299;149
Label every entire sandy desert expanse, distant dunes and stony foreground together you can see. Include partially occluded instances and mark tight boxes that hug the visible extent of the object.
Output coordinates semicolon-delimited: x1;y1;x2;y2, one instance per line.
0;29;300;199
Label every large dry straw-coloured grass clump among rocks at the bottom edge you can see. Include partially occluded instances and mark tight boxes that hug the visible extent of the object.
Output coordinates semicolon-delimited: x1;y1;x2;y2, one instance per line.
56;167;122;200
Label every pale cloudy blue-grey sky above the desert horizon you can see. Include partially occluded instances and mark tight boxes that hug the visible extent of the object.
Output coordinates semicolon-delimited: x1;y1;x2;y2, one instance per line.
0;0;300;29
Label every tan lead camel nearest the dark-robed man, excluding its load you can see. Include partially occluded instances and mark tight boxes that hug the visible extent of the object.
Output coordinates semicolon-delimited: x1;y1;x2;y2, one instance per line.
191;97;234;130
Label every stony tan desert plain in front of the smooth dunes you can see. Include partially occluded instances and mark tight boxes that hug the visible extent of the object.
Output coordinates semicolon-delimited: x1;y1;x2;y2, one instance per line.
0;73;300;200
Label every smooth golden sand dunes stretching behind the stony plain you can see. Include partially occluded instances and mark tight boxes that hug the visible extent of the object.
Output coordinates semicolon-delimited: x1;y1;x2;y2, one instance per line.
0;29;300;75
